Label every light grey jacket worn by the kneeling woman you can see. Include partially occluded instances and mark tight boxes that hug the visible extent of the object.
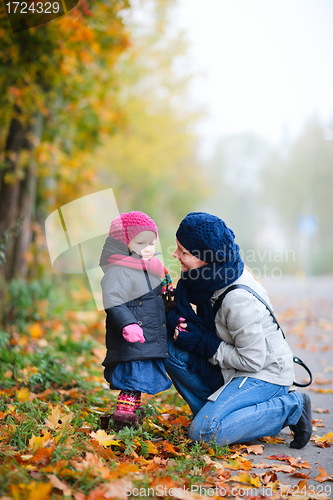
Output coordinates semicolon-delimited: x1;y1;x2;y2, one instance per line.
208;269;294;401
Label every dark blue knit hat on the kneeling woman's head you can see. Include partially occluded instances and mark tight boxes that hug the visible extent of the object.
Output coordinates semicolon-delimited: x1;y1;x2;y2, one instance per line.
176;212;239;264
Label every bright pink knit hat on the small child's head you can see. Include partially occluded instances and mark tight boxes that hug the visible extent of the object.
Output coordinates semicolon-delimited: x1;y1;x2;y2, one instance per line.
109;212;158;245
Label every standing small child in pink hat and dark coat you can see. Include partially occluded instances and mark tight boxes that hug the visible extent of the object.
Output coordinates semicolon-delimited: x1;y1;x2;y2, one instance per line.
100;212;172;428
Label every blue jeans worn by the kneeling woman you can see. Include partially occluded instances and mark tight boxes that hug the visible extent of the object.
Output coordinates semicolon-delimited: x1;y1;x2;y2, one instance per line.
164;338;303;446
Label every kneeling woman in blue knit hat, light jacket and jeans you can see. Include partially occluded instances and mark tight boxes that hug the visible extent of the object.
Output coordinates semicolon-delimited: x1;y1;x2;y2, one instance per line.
164;212;312;449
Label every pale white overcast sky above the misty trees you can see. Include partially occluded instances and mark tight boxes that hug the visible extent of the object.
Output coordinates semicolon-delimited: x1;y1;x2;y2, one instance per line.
175;0;333;150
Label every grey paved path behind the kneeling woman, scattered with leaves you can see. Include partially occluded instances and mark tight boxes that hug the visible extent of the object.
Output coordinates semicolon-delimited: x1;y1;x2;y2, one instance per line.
249;276;333;498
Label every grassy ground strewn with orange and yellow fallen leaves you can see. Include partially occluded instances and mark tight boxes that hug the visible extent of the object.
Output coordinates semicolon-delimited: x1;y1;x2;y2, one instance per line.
0;280;333;500
